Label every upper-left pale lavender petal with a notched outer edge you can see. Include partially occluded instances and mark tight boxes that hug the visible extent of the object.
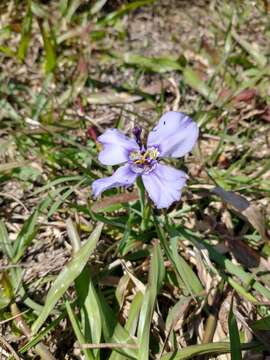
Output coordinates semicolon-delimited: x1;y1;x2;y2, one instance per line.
98;129;139;165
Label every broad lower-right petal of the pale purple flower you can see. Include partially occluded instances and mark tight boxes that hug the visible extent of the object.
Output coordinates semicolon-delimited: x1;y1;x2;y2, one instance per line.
142;164;187;209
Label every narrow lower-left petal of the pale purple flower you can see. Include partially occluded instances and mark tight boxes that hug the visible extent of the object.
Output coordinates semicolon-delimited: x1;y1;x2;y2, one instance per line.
92;164;138;197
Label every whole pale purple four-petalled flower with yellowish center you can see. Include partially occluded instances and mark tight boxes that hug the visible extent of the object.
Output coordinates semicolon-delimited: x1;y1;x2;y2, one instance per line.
92;111;199;209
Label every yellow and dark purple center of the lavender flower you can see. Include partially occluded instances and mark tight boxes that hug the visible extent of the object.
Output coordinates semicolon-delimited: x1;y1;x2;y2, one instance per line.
129;146;159;174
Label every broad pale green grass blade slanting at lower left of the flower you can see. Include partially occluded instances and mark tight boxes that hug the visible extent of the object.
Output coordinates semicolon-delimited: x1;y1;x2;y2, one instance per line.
32;224;103;334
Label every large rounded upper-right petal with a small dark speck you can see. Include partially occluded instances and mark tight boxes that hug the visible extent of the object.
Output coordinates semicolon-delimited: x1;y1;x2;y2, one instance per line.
147;111;199;158
